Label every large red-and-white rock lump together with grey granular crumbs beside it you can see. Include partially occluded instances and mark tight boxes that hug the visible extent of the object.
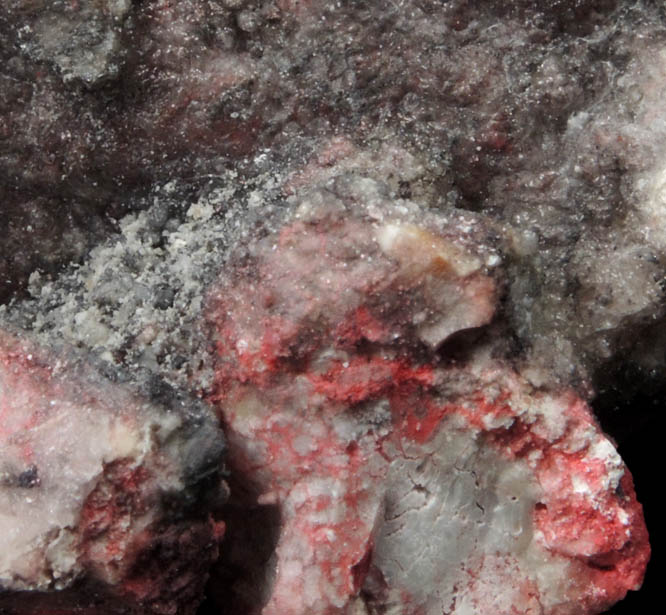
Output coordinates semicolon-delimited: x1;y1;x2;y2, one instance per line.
0;147;649;613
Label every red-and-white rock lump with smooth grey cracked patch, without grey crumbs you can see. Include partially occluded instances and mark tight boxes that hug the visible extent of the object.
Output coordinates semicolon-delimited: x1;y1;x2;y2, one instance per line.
209;196;649;615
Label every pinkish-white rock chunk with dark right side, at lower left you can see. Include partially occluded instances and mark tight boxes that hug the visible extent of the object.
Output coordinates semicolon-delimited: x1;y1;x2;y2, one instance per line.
0;332;224;614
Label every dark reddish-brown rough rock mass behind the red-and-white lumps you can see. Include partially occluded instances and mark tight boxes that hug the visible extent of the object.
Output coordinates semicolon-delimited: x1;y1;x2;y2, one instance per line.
0;0;664;385
